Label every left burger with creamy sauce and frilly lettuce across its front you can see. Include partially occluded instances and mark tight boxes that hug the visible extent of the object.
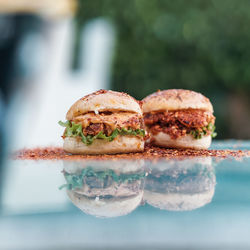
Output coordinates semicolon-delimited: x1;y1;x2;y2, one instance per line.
59;90;145;154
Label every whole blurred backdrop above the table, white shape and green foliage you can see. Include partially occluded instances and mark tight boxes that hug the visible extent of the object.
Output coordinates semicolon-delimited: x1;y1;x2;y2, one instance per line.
0;0;250;152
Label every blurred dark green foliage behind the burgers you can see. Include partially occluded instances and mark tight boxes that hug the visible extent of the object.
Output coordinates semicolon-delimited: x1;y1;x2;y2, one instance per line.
76;0;250;138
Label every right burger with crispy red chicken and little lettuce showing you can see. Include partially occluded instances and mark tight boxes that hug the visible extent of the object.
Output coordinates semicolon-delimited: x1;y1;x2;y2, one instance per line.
142;89;216;149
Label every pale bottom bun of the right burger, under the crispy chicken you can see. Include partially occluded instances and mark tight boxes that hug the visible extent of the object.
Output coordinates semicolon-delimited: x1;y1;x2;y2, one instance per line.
151;132;211;149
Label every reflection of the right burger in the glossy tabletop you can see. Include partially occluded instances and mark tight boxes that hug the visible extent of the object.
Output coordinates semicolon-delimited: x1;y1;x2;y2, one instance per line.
144;158;216;211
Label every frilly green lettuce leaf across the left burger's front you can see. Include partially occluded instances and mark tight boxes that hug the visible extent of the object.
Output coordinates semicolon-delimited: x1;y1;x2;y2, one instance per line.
58;121;145;145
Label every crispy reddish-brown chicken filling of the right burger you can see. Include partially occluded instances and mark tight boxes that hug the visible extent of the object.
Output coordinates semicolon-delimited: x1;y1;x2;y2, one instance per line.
144;109;215;139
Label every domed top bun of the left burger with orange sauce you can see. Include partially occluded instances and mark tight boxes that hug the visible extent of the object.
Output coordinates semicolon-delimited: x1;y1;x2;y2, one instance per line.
66;90;142;120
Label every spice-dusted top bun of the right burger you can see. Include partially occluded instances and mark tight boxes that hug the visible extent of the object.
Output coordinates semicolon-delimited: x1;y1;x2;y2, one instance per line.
142;89;213;113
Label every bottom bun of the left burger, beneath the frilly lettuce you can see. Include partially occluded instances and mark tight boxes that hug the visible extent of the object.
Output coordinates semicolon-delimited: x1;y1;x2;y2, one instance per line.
63;136;144;154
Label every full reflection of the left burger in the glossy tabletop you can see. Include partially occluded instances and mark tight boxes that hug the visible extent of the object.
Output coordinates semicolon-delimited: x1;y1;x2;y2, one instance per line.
61;161;145;218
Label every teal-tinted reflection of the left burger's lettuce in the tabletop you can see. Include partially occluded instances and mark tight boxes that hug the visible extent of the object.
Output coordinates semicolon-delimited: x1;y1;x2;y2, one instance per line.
59;167;145;190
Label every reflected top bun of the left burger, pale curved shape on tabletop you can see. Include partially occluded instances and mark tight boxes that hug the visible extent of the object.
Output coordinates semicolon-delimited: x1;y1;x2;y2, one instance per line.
67;190;143;218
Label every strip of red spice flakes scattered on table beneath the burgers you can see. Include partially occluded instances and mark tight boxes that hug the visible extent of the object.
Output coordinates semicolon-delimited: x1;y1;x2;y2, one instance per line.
12;145;250;160
